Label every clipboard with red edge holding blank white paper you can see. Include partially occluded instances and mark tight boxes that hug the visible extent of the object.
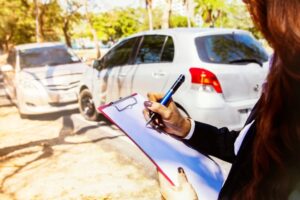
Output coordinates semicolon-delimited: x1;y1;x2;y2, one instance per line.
98;93;224;200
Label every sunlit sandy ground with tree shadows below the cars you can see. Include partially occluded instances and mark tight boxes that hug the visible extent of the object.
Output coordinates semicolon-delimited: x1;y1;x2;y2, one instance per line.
0;106;161;200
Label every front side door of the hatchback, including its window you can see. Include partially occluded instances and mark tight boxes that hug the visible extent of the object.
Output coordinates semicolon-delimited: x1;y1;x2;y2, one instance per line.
92;38;137;105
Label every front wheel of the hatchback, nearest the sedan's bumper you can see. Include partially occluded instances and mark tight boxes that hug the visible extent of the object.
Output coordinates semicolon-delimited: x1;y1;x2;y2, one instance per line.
78;89;99;121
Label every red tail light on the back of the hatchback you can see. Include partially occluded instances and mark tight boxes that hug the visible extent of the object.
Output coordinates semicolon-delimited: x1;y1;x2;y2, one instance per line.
190;68;222;93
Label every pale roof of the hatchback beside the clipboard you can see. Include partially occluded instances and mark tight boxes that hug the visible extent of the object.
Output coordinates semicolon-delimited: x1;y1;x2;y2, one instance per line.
124;28;249;39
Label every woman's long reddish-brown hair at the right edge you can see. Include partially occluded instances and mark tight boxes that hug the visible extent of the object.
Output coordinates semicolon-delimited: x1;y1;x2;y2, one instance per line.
238;0;300;199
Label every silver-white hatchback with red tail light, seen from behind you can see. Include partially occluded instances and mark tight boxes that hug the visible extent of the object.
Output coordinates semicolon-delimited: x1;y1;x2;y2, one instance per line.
79;28;269;129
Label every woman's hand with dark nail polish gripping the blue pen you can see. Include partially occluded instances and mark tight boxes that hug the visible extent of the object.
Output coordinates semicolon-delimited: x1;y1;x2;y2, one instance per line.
144;93;191;138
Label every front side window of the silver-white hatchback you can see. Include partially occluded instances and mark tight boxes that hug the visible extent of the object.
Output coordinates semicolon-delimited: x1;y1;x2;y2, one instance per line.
103;38;136;68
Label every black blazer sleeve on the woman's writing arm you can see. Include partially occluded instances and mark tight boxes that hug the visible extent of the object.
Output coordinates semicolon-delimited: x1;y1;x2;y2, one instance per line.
184;121;239;163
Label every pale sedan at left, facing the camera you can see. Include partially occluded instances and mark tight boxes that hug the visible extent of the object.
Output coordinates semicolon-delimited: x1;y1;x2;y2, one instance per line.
1;43;88;117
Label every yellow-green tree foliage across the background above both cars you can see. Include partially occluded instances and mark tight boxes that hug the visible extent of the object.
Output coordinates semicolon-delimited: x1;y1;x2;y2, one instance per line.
0;0;261;51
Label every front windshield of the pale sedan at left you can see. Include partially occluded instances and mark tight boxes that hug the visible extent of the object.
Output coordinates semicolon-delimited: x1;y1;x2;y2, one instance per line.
20;45;80;68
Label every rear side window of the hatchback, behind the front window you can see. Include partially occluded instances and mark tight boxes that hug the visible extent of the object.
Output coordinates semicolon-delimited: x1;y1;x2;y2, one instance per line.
135;35;166;64
